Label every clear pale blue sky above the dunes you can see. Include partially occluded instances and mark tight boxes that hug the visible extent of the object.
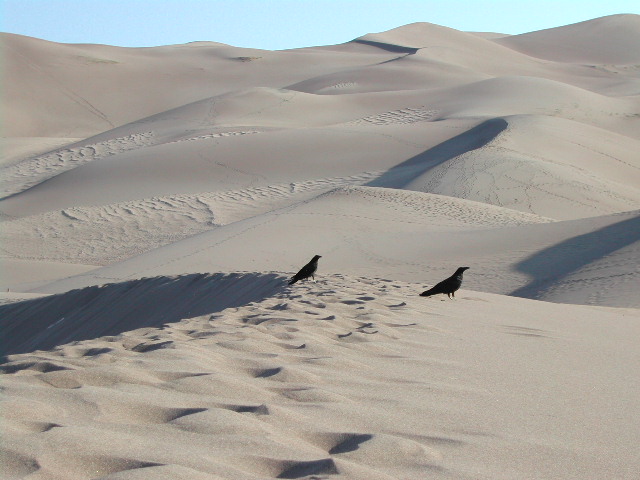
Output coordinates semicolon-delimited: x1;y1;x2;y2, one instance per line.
0;0;640;50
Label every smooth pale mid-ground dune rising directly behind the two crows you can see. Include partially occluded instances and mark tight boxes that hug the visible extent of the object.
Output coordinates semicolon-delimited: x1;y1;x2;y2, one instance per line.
18;187;640;307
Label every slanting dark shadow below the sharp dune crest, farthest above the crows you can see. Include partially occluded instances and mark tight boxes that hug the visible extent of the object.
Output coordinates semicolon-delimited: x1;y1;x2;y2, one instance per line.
365;118;509;188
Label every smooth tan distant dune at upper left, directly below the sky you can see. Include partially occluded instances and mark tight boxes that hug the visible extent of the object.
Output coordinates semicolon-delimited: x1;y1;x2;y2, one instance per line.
2;34;393;137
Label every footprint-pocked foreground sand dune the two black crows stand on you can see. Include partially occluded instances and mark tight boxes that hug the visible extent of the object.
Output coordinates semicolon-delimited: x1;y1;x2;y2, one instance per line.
0;275;640;479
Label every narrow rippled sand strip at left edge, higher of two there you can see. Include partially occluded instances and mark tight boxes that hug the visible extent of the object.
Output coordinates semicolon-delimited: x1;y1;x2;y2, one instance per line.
0;132;154;198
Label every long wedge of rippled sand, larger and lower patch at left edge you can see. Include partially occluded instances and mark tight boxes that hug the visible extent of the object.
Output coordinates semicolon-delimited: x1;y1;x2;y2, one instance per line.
0;172;381;265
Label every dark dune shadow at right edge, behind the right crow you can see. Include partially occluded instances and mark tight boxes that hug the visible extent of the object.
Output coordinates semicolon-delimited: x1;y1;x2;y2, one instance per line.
509;215;640;299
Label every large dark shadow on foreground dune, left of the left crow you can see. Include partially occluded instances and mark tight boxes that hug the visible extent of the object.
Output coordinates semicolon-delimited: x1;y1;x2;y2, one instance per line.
0;273;287;360
